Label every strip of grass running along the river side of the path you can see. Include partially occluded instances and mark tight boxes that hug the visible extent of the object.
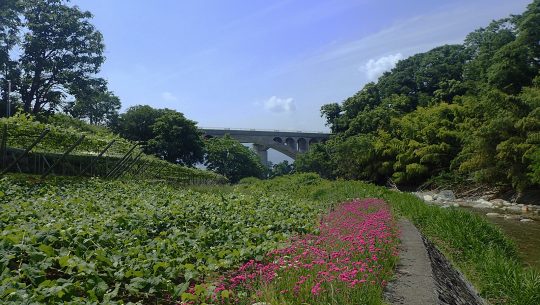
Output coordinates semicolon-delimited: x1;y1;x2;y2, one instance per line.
239;174;540;305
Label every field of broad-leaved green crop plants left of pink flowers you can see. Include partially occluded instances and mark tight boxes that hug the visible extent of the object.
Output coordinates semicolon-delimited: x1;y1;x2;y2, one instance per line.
0;177;324;304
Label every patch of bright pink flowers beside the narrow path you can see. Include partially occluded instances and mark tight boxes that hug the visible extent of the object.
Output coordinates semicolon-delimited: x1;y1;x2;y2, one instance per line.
184;199;398;304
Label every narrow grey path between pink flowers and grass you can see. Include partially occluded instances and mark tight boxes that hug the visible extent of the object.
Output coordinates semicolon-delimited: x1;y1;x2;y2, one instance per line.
385;219;438;305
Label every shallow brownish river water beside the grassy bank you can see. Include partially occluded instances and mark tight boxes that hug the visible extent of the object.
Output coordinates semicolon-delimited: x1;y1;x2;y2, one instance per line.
463;207;540;270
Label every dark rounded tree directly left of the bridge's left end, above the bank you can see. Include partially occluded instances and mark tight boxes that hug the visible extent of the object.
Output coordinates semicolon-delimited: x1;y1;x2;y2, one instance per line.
146;109;204;166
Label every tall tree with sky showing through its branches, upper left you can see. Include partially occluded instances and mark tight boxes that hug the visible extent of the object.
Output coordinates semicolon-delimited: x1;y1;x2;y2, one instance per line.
2;0;104;114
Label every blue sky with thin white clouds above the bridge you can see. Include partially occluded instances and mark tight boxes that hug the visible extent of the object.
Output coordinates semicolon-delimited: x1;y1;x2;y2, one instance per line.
72;0;530;131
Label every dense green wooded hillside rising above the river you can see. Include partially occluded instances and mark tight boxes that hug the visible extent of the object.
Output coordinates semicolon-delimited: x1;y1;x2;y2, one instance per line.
302;0;540;190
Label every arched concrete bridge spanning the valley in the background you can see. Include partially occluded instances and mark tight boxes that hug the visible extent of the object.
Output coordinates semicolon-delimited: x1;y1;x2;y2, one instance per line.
200;128;330;164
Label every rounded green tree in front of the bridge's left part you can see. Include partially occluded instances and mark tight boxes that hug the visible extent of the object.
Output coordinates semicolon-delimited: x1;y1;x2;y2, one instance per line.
204;135;267;183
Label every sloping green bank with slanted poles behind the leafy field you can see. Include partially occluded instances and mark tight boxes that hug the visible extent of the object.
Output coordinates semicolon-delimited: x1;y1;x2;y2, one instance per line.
0;114;226;184
